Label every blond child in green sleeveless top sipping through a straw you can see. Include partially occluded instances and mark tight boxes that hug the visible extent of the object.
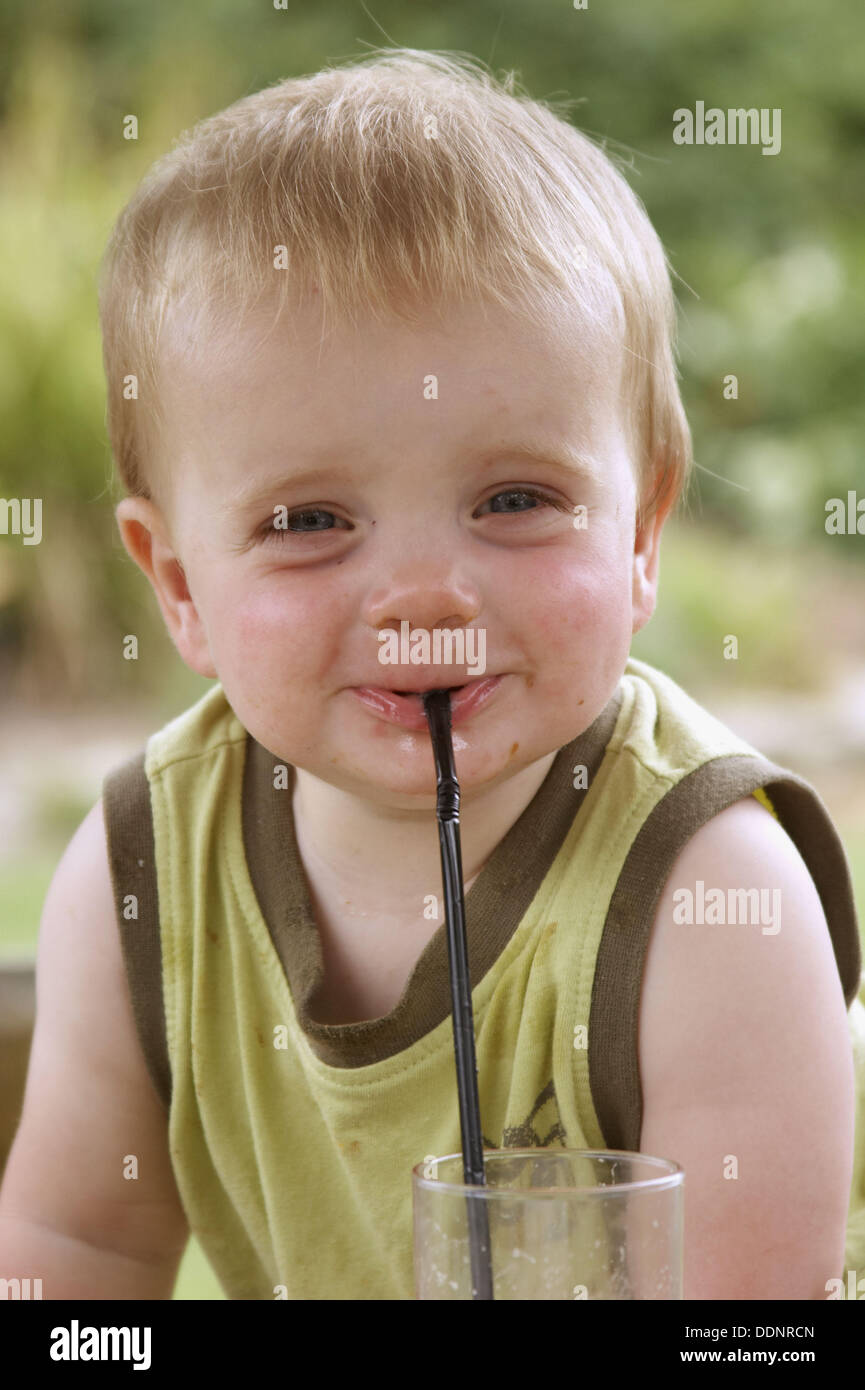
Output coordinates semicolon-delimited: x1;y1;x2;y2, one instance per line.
0;50;865;1300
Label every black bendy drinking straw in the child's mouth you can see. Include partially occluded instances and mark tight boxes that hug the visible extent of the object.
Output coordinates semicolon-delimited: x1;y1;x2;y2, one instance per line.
421;691;494;1298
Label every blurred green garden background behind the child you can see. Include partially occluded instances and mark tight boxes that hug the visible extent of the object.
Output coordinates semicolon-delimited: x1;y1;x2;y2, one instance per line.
0;0;865;1298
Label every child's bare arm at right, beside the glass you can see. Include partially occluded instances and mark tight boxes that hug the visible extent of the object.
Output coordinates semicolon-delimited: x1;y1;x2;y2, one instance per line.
640;796;855;1300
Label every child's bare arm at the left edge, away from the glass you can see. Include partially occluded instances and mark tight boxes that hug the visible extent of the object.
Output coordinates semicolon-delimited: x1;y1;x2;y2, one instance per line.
0;801;189;1298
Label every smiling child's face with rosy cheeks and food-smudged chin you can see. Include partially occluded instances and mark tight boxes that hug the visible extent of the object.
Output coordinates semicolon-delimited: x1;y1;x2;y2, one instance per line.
117;293;663;809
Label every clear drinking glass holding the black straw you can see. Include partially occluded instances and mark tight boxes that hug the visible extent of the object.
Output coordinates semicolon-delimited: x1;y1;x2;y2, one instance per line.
412;1148;684;1300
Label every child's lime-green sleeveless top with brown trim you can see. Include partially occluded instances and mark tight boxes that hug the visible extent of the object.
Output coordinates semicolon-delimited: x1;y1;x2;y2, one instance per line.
103;657;865;1300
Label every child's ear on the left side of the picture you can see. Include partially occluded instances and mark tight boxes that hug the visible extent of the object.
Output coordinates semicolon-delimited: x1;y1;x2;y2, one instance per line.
114;498;218;680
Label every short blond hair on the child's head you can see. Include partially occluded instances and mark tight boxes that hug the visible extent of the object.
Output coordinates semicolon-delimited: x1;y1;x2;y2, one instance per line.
99;49;693;520
